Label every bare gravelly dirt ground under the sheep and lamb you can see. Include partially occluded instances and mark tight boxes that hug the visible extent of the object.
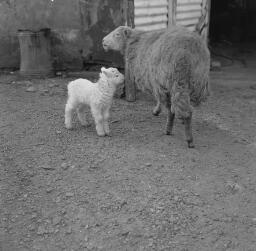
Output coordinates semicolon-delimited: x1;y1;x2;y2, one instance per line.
0;59;256;251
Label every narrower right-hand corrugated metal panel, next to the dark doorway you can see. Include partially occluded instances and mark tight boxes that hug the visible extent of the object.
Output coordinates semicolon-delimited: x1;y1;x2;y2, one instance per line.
176;0;202;30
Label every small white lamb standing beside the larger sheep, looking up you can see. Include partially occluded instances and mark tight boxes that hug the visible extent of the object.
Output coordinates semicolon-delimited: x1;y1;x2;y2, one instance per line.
65;67;124;136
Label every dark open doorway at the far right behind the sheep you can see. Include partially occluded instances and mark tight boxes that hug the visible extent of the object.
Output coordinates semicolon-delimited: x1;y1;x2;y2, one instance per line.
209;0;256;65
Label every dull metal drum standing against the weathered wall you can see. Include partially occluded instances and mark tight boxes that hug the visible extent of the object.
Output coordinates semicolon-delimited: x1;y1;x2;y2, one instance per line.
18;29;53;77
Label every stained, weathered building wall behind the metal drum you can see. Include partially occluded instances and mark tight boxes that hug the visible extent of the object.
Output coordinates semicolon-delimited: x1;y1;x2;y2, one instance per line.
0;0;125;69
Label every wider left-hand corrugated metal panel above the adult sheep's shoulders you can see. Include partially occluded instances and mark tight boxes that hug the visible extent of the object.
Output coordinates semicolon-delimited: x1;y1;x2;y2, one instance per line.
134;0;168;31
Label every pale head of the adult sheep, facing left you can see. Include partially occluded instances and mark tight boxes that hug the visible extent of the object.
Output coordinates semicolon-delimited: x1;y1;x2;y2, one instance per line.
102;26;132;54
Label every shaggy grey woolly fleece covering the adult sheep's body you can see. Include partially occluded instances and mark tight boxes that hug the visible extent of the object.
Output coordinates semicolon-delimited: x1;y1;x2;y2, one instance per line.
125;26;210;104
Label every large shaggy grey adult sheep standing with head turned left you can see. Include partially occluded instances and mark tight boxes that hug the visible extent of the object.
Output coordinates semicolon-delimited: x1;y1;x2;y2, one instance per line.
102;26;210;148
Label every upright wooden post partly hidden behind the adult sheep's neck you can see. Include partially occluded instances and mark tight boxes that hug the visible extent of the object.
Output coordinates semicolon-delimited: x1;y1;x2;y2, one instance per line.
124;0;136;102
